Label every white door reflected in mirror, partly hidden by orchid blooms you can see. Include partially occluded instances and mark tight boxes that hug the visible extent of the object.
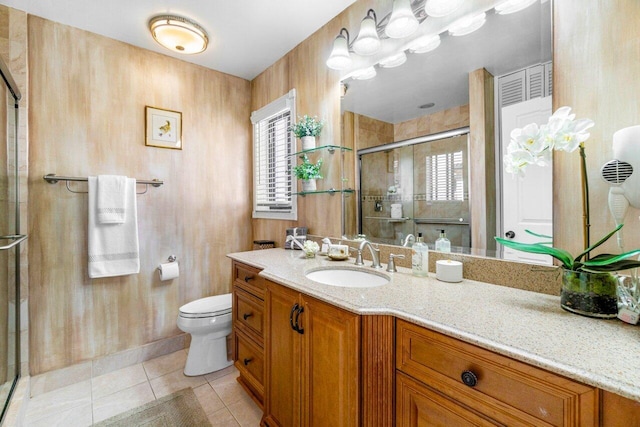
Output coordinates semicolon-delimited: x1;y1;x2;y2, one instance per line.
502;96;553;265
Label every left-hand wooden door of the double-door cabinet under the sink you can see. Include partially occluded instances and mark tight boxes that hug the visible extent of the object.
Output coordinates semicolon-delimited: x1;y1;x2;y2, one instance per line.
264;281;302;427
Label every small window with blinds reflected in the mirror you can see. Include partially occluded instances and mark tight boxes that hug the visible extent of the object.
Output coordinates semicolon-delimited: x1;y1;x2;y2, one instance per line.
426;151;464;201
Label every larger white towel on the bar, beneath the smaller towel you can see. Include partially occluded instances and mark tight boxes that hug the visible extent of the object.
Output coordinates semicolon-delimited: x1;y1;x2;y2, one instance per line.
88;176;140;279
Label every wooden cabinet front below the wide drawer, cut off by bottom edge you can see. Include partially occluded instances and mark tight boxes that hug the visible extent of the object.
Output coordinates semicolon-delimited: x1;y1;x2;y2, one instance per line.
396;371;499;427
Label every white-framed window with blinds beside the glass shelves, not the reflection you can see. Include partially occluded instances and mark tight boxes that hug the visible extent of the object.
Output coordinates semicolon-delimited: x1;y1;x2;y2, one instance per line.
251;89;297;220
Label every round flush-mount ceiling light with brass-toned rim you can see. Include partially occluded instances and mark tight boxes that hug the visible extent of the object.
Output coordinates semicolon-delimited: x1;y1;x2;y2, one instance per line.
149;15;209;54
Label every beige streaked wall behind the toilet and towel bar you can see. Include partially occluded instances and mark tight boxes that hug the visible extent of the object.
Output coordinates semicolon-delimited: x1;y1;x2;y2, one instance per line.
29;16;251;374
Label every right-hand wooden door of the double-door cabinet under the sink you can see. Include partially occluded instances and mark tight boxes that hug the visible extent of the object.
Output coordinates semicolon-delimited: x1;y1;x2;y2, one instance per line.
299;295;360;427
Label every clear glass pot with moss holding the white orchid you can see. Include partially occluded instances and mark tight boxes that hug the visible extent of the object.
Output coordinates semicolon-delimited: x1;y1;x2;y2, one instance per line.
560;269;618;319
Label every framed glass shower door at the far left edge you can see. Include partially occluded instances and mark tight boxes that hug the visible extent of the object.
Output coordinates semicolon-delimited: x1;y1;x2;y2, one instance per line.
0;54;27;422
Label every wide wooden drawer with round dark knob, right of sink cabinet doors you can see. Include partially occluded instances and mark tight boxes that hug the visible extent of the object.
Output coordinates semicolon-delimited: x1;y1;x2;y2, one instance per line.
396;320;597;426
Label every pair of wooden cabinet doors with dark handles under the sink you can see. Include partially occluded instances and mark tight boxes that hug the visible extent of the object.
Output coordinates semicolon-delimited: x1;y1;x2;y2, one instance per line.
262;281;360;427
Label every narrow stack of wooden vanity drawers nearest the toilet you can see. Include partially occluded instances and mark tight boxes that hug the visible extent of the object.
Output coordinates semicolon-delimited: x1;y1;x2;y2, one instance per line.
232;261;265;407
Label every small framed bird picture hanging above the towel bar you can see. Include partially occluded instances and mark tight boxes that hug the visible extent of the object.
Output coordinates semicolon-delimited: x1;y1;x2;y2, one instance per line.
144;105;182;150
